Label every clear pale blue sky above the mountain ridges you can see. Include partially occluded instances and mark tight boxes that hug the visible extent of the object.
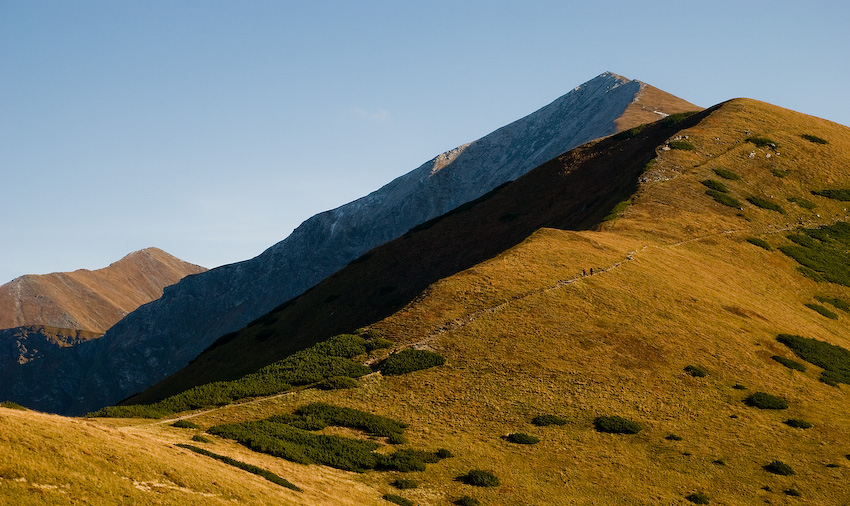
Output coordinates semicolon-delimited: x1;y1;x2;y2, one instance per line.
0;0;850;283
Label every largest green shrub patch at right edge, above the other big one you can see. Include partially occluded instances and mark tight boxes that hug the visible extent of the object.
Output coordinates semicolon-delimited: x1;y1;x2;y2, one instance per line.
778;221;850;286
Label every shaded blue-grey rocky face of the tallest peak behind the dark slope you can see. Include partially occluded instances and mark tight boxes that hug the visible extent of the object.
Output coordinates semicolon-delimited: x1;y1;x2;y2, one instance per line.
0;73;644;414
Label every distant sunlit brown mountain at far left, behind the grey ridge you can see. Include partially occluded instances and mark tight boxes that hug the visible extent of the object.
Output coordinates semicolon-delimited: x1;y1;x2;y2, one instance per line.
0;248;206;333
